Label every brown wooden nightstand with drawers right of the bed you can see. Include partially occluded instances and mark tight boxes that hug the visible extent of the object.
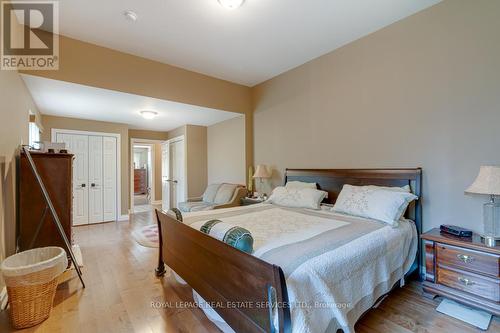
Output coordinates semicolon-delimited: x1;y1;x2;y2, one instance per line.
421;228;500;316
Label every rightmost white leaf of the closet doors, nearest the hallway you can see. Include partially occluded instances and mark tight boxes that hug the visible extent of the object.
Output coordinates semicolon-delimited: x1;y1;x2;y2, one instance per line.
102;136;118;221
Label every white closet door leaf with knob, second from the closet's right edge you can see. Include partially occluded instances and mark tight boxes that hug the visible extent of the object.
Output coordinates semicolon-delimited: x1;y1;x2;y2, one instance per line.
89;135;104;223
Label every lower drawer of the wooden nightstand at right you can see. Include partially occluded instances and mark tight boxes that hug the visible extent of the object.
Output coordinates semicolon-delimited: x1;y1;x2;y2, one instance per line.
437;267;500;302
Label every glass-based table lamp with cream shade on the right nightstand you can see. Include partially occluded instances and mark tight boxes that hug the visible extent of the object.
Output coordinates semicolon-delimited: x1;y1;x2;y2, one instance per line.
465;166;500;247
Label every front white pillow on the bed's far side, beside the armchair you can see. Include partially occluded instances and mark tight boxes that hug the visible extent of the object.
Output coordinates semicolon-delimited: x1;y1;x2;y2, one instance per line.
267;186;328;209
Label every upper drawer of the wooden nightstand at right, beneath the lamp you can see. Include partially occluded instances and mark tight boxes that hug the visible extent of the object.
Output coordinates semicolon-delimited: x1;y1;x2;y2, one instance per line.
436;243;500;277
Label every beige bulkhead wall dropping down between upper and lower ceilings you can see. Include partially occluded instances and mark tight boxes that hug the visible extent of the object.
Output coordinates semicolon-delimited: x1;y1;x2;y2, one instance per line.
20;36;253;183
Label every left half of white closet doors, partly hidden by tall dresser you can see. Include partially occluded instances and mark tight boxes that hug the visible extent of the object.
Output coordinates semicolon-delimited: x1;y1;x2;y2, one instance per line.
56;133;89;225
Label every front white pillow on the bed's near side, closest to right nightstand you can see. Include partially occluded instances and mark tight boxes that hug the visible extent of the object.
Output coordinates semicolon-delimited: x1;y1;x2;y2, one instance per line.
333;184;418;226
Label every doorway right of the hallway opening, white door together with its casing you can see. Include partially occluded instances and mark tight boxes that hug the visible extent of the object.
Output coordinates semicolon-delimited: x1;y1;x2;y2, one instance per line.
161;136;187;211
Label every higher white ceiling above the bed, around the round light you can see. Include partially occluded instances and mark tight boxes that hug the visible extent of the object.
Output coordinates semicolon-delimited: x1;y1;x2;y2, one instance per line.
59;0;441;86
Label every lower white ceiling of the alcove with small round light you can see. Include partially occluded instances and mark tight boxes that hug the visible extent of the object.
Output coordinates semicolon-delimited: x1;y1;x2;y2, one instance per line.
22;74;241;131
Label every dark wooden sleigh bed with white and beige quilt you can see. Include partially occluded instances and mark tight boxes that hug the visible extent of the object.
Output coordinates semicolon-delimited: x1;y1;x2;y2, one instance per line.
156;168;422;332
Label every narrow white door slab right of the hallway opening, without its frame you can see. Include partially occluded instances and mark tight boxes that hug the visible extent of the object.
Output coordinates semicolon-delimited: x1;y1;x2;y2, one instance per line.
170;139;186;207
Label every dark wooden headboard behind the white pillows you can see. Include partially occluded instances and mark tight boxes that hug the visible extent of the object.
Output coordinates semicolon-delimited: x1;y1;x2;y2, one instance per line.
285;168;422;275
